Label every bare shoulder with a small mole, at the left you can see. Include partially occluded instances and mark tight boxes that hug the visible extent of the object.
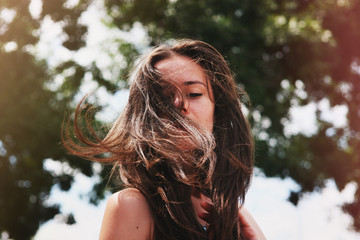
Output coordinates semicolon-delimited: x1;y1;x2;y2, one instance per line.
100;188;153;240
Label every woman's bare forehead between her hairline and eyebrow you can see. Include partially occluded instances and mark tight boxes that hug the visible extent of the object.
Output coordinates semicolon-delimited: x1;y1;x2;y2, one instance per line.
154;55;207;86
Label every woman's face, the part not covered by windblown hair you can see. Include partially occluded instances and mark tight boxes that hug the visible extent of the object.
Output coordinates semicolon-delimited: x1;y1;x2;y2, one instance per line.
155;55;215;132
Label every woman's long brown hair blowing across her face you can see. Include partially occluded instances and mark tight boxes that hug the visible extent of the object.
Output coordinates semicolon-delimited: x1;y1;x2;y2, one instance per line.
63;40;253;240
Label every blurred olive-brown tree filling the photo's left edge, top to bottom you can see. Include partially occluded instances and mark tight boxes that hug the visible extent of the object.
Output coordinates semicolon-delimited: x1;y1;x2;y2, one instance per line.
0;0;92;239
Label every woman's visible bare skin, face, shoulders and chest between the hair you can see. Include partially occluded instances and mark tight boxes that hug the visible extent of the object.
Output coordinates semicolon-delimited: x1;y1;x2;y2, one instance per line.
100;56;265;240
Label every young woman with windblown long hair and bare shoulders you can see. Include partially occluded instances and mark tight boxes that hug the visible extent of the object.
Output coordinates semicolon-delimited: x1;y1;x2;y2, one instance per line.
65;40;265;240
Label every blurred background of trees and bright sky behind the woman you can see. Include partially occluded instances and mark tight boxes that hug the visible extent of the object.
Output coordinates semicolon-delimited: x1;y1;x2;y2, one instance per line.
0;0;360;240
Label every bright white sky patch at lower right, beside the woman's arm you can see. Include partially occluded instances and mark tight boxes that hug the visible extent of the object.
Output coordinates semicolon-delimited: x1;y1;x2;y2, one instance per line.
245;172;360;240
